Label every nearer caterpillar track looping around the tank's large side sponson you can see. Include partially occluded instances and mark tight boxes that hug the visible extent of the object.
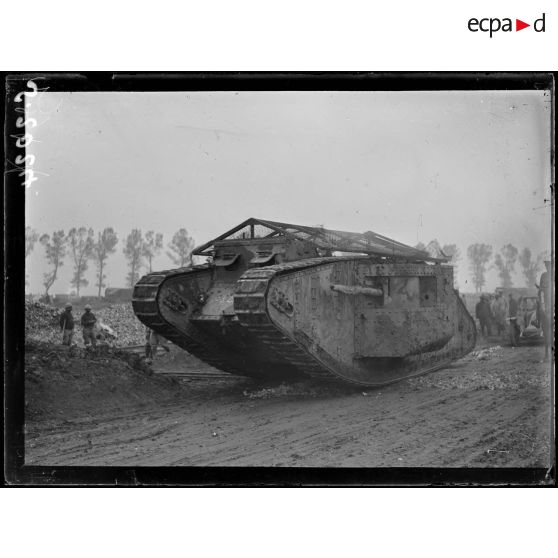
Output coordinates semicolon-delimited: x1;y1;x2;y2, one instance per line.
235;257;476;386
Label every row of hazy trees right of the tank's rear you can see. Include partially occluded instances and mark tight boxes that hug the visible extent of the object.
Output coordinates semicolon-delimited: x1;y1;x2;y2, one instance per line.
416;240;548;293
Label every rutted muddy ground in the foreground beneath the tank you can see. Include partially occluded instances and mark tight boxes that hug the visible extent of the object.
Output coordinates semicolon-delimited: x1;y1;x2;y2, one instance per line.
25;336;551;467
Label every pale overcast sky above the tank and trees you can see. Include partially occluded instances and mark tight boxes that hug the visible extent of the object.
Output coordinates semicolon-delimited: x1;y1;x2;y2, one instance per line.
26;91;551;294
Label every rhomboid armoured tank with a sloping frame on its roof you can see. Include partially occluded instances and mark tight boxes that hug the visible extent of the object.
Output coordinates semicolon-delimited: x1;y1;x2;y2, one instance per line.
132;218;476;386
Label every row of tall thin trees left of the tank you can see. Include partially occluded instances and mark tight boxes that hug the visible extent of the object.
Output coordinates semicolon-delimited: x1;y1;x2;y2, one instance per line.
25;227;194;297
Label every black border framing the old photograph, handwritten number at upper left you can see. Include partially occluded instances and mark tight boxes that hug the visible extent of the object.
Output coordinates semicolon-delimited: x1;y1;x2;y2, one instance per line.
2;71;556;487
